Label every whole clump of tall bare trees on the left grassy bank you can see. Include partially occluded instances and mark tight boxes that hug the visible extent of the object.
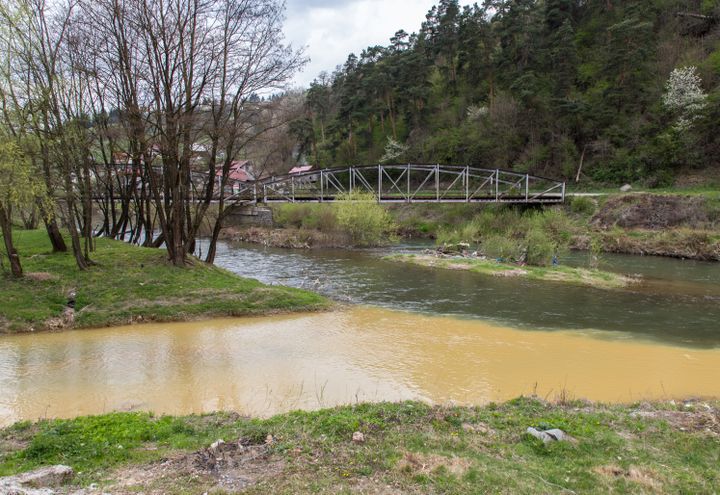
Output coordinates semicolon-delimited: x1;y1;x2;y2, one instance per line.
2;0;305;268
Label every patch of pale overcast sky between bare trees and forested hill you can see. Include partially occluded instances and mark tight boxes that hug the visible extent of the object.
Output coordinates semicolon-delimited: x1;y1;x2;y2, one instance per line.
285;0;436;87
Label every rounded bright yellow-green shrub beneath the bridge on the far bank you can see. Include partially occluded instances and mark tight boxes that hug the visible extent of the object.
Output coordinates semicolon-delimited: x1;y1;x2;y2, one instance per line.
333;192;394;246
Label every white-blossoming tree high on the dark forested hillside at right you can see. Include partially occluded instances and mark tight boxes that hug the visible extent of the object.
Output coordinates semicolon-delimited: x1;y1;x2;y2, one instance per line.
663;66;707;127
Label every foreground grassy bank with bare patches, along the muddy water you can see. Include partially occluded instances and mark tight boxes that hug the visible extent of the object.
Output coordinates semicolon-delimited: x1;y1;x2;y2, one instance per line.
0;398;720;494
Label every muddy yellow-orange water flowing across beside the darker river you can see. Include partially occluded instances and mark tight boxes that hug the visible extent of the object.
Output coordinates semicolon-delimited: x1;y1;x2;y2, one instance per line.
0;307;720;425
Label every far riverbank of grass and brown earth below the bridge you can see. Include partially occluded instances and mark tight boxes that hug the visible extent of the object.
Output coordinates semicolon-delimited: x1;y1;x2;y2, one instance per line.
222;192;720;261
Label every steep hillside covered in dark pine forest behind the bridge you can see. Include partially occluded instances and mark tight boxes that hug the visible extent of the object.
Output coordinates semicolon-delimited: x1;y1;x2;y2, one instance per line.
291;0;720;186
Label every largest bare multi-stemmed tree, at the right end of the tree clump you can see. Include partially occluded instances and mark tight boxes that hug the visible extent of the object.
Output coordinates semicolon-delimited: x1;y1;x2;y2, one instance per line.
76;0;304;264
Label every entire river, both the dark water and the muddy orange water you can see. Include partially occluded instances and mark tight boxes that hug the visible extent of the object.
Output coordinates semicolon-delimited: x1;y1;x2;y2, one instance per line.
0;243;720;425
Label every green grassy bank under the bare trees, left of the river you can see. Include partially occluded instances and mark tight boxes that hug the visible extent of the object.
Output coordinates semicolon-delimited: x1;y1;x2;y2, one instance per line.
0;231;327;332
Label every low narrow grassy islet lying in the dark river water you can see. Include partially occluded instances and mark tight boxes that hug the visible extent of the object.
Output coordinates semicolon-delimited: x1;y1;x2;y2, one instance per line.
383;253;638;289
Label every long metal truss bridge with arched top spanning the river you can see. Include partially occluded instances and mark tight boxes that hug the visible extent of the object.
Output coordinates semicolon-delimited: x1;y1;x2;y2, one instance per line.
226;164;565;203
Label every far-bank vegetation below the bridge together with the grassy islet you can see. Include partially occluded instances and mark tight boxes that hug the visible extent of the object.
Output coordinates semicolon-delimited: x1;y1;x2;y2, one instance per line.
225;191;720;280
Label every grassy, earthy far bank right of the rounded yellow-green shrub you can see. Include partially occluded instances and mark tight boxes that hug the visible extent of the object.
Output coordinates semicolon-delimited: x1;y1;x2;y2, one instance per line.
389;192;720;261
